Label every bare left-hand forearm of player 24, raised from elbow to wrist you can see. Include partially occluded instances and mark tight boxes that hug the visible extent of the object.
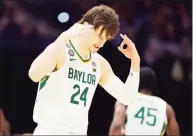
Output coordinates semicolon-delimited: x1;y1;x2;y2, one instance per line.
28;33;68;82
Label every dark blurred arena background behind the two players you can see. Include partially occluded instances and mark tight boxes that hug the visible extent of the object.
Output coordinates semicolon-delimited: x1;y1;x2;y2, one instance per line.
0;0;192;135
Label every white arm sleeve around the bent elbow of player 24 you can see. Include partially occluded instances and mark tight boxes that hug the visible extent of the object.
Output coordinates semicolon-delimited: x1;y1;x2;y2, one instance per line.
103;69;139;105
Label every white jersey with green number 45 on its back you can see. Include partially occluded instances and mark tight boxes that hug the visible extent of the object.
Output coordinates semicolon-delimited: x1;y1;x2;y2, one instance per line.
125;93;167;135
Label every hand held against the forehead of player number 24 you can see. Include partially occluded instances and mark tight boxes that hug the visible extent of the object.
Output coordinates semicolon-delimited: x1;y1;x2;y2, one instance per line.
66;22;94;38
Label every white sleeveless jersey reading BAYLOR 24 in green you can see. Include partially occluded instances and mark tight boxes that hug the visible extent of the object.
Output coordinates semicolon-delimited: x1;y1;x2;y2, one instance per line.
33;42;100;134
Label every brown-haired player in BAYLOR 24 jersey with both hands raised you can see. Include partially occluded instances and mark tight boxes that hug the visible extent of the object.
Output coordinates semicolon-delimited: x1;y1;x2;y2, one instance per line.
29;5;140;135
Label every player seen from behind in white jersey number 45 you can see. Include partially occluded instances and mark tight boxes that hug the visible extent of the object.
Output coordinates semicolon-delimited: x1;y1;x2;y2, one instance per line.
109;67;180;136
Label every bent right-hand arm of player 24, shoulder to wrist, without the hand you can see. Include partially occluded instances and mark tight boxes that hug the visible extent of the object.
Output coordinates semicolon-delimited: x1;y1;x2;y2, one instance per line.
99;54;140;105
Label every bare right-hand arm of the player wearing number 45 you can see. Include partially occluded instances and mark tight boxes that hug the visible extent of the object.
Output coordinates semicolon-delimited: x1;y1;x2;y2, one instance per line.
166;105;180;136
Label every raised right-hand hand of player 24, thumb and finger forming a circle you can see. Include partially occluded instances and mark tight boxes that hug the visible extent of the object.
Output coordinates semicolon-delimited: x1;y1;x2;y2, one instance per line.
118;34;140;61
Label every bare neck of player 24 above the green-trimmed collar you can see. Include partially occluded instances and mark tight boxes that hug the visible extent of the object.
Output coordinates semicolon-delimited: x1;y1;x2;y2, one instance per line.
71;39;90;60
